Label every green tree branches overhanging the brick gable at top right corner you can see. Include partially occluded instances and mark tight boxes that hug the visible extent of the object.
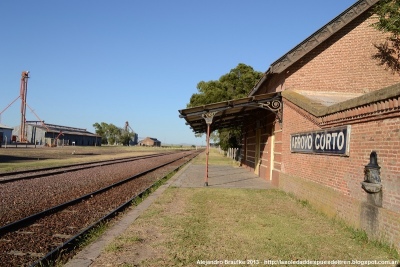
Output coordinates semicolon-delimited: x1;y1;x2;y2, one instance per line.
372;0;400;72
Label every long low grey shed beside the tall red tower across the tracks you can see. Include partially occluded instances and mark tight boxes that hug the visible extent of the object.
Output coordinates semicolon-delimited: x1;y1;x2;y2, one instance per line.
13;121;101;146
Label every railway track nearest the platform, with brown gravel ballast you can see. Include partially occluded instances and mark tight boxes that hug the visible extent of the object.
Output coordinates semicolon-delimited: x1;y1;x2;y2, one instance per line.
0;151;201;266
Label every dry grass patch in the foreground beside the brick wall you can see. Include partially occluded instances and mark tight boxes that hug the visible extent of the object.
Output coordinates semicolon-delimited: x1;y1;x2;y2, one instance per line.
98;188;398;266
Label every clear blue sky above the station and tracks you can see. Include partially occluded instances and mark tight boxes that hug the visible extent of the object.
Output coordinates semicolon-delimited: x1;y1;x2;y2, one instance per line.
0;0;356;145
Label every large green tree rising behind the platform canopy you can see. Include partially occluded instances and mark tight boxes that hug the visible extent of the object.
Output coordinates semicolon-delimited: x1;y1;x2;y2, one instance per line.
187;63;263;150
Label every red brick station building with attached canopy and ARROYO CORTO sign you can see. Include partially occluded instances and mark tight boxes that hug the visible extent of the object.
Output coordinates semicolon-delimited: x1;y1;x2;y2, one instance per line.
180;0;400;250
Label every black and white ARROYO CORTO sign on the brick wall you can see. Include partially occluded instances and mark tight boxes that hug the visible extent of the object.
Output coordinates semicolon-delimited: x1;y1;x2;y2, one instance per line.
290;125;351;156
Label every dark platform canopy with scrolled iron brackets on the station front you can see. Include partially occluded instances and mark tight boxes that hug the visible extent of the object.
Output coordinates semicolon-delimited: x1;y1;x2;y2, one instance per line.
179;92;282;133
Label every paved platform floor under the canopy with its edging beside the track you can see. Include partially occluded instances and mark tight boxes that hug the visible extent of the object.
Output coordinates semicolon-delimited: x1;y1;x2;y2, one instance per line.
64;163;273;267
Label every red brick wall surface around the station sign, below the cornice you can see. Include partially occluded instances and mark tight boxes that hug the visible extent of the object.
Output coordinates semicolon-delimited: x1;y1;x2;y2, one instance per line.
279;101;400;249
